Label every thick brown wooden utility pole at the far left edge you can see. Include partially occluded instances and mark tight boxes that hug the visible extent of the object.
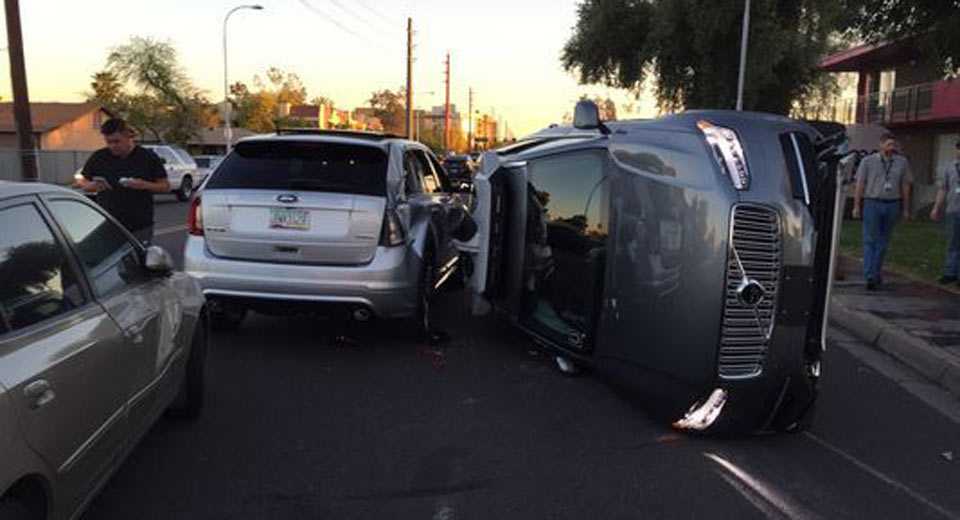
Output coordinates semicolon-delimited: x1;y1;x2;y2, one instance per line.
4;0;38;182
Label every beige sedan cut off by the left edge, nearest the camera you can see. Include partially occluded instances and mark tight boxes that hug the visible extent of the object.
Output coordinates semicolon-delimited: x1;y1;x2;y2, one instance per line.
0;183;207;520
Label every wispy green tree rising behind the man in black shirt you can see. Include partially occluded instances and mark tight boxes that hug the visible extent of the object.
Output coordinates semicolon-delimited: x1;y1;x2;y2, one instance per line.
87;36;216;144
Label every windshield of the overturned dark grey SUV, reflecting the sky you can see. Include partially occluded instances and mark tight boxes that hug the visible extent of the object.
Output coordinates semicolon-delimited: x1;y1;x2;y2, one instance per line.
520;149;610;351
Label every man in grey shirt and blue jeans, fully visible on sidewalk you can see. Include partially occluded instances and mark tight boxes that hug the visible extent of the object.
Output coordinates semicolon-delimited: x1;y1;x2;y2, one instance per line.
853;133;913;291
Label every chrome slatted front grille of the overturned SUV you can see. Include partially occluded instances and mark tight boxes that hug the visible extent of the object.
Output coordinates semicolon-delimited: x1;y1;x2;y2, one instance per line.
719;204;781;379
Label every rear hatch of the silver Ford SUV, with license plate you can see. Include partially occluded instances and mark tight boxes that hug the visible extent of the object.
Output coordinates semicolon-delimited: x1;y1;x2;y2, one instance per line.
201;139;388;265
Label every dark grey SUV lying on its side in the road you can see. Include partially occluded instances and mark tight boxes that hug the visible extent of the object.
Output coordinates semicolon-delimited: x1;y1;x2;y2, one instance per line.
460;102;840;432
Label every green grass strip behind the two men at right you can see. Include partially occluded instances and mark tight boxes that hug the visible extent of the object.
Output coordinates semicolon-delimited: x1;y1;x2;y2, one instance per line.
840;220;947;282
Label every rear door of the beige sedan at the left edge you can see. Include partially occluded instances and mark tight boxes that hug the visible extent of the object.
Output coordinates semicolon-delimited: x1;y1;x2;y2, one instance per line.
0;197;131;509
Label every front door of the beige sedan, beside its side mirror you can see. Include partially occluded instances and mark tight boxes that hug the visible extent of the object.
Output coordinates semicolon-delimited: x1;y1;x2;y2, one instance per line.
47;198;182;440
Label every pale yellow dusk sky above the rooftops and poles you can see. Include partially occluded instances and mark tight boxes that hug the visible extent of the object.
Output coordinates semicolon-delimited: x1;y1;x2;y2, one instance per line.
0;0;655;136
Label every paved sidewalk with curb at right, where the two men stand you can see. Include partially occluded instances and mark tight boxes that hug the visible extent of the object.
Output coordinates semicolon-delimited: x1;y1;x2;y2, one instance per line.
830;258;960;398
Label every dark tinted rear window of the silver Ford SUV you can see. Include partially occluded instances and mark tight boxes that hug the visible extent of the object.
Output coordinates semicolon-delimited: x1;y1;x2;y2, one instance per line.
206;141;387;196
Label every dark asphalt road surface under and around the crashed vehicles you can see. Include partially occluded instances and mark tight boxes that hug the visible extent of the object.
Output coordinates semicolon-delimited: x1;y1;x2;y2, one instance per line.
84;198;960;520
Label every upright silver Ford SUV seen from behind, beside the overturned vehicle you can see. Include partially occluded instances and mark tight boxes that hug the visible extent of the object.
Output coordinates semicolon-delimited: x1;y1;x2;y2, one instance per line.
184;130;474;331
